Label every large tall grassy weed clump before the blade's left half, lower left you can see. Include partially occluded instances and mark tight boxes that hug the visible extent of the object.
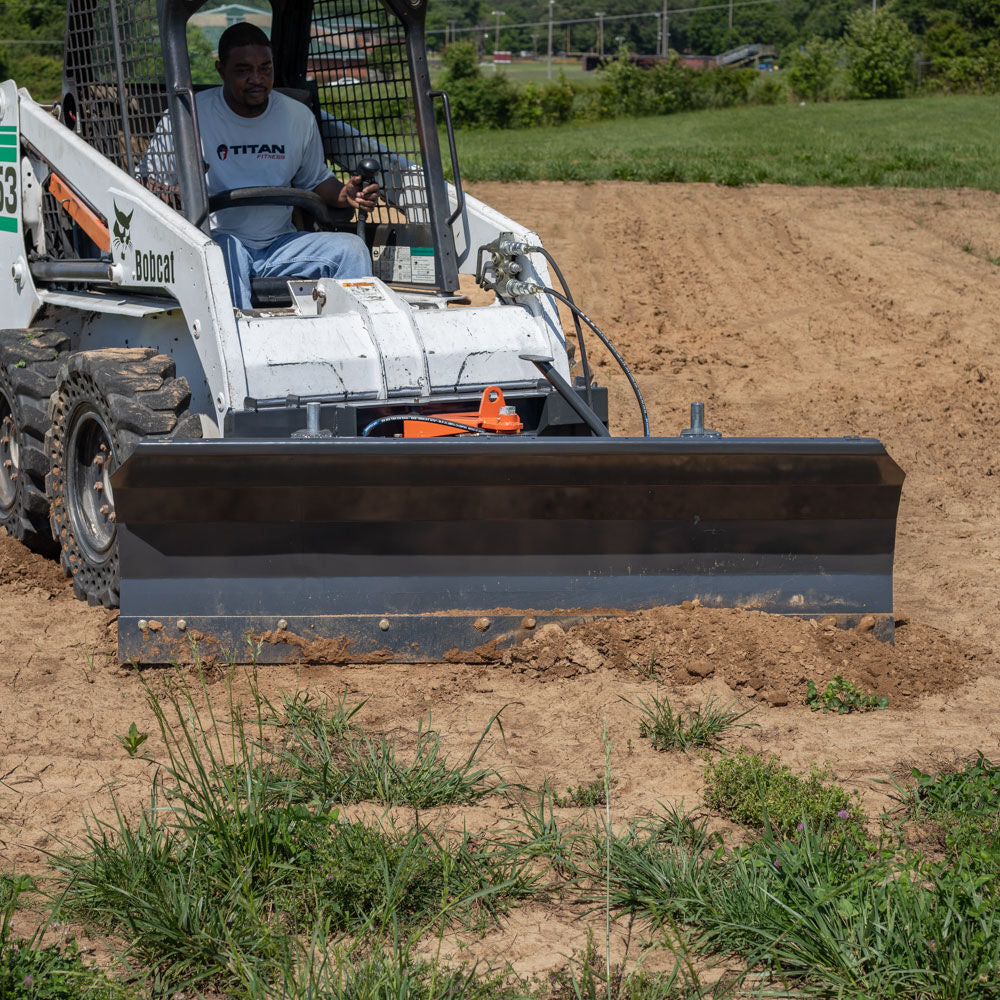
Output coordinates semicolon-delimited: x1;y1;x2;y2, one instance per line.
47;682;541;992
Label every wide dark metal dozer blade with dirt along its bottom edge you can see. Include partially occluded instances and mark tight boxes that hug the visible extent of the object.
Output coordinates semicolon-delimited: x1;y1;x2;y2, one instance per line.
112;437;903;663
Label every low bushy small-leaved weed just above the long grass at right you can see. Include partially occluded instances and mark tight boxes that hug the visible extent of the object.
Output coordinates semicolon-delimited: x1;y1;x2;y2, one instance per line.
705;747;864;837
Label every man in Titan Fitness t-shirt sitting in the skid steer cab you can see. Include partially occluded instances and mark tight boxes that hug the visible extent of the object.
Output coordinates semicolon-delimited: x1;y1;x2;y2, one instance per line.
146;22;378;309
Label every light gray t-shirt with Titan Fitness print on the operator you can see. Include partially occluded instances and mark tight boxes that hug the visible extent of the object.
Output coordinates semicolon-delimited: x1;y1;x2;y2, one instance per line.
196;87;333;249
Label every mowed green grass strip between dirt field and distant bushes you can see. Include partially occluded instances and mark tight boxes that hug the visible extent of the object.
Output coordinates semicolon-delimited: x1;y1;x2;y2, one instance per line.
458;96;1000;191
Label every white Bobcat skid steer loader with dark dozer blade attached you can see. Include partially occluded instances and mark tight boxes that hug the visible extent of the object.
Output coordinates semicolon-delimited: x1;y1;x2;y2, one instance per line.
0;0;903;663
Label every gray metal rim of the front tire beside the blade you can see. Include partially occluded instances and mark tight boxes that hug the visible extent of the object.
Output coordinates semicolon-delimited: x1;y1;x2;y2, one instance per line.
66;405;116;563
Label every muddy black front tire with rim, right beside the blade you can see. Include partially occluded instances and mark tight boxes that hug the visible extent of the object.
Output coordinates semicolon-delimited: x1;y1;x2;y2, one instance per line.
45;348;201;608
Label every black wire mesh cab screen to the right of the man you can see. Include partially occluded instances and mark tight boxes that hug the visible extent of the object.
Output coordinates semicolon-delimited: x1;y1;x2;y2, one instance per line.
306;0;440;286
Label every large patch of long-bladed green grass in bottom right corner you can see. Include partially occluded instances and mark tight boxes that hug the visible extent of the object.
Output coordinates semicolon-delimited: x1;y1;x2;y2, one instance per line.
584;804;1000;1000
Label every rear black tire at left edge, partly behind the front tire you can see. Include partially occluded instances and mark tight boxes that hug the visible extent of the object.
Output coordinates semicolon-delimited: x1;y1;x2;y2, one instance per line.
0;330;69;555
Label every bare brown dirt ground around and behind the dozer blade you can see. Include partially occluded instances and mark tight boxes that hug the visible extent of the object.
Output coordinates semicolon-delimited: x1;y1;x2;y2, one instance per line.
0;184;1000;972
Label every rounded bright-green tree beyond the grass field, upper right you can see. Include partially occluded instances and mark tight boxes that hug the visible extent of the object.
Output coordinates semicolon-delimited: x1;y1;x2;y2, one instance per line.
845;7;916;98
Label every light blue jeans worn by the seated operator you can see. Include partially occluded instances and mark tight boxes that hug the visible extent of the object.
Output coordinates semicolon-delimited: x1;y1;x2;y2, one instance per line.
212;233;372;309
